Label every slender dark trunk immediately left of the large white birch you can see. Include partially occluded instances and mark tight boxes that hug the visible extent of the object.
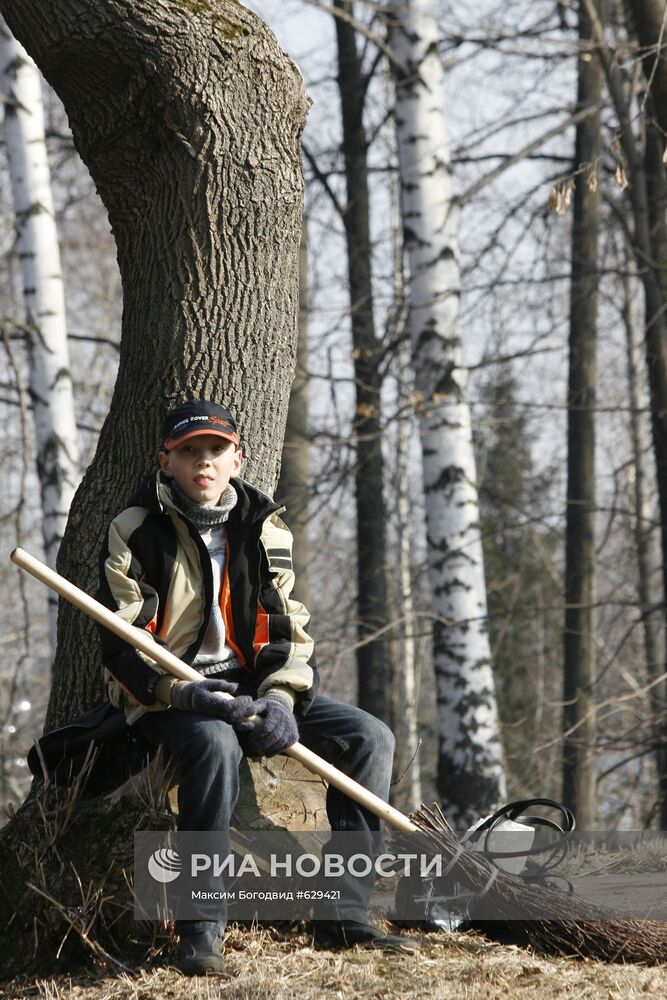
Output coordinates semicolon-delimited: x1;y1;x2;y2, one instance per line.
334;0;390;722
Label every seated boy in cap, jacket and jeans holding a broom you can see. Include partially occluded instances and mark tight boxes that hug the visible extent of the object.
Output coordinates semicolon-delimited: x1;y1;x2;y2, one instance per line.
99;400;405;974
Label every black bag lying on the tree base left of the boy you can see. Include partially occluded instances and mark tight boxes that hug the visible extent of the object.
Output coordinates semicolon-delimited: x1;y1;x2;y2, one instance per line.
28;701;154;796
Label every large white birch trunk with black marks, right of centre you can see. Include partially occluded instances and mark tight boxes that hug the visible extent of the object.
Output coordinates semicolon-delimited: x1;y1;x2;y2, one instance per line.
390;0;505;822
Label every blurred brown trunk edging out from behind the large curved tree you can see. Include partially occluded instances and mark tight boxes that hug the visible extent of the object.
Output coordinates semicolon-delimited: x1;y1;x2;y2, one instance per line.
275;219;310;608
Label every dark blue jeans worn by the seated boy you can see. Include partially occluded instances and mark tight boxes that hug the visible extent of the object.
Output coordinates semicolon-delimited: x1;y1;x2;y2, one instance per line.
136;694;394;935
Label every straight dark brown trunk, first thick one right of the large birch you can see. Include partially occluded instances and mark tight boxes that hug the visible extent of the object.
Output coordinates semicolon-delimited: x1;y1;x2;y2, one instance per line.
563;0;602;830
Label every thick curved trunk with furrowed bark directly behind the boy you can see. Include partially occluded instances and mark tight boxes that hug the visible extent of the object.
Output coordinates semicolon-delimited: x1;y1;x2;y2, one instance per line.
0;0;307;726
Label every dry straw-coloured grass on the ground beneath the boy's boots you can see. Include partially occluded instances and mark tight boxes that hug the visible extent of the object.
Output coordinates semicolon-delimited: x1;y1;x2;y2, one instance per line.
0;928;667;1000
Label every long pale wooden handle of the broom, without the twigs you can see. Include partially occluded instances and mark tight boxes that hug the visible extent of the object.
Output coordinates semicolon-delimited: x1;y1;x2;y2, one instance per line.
10;548;418;833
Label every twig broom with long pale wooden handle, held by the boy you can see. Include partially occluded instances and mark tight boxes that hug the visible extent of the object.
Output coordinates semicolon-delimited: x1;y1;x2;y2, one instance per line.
10;548;667;965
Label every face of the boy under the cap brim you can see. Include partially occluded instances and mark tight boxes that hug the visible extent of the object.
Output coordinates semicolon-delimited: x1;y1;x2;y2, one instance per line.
160;434;243;504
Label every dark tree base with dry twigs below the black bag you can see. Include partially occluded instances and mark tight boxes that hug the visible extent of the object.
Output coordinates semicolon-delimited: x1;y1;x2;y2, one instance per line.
0;754;174;974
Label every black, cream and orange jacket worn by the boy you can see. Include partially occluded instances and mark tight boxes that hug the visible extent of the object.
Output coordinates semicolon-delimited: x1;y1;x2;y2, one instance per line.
98;472;317;722
